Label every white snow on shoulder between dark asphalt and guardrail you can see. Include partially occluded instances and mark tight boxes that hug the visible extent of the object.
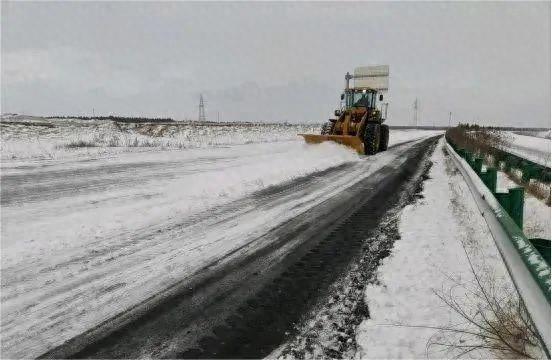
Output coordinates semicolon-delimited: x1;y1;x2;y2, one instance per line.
357;142;532;358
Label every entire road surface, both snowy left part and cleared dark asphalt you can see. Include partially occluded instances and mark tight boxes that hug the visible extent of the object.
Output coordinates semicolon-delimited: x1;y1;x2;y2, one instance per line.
1;134;440;358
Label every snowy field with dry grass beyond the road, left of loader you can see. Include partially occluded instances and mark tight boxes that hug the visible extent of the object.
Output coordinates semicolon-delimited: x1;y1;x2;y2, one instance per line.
0;118;319;161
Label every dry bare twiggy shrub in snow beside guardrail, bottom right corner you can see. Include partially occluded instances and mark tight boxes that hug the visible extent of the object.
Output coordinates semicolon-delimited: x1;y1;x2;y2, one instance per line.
427;251;544;359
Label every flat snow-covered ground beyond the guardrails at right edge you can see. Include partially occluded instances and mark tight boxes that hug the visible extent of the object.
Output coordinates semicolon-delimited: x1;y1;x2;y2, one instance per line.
504;132;550;167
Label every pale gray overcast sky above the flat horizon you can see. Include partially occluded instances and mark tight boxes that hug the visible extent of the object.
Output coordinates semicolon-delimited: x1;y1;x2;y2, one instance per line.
1;2;550;127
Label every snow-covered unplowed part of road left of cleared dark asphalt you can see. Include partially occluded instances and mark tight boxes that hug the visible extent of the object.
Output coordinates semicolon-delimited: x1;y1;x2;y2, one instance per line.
1;131;440;358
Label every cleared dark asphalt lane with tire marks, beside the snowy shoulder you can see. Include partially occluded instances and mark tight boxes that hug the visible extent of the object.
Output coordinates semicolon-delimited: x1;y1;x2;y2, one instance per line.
33;137;437;358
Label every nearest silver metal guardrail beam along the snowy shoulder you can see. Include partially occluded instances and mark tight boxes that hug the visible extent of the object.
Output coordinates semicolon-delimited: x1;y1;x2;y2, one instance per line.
447;139;551;354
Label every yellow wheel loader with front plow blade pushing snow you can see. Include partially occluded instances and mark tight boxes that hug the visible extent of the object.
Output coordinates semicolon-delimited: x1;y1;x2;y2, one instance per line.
299;65;389;155
